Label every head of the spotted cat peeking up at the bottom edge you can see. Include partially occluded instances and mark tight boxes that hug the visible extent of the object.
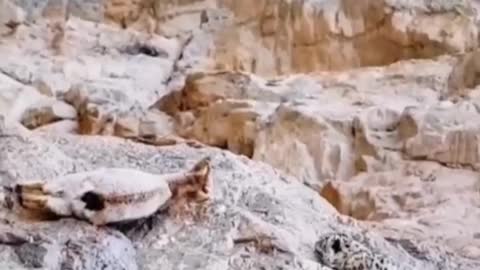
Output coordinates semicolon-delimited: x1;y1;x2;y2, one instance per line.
315;232;354;269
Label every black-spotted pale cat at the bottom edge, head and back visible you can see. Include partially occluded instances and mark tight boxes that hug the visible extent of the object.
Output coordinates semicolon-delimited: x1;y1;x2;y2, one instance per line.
315;233;400;270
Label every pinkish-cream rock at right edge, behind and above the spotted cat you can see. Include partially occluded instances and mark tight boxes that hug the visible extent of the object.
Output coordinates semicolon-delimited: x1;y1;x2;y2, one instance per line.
325;161;480;260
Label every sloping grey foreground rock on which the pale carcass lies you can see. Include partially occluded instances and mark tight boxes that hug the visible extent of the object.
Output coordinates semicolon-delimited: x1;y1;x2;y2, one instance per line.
0;121;478;269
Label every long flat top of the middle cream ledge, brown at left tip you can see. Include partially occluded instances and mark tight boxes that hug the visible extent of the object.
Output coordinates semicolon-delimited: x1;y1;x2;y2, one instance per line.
153;57;452;115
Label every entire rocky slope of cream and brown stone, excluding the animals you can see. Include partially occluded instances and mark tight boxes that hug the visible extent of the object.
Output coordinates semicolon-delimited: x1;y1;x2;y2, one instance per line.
0;0;480;270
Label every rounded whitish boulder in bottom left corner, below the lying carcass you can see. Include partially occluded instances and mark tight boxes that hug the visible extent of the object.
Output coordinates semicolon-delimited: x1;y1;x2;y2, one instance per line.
0;218;139;270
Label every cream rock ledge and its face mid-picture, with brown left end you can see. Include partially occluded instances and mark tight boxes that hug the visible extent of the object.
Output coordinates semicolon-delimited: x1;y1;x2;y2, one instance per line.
155;58;458;187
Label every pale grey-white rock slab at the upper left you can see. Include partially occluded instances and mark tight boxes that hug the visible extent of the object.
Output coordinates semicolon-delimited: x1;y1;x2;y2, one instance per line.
0;17;181;118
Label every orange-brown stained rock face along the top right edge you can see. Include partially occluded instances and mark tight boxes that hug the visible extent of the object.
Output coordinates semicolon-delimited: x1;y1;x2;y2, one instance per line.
149;0;477;75
